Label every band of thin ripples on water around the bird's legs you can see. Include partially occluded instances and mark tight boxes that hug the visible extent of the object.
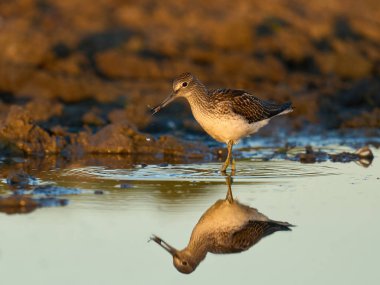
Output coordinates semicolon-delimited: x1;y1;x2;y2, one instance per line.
64;161;339;182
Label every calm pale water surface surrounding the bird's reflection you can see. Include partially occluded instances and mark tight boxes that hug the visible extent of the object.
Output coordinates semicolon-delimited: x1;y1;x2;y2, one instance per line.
0;146;380;285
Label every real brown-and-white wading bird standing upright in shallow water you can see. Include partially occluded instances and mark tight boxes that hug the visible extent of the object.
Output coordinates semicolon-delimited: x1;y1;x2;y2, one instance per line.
153;72;292;172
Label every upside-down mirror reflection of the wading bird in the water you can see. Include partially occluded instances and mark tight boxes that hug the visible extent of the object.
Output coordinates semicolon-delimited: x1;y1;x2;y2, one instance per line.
150;173;293;274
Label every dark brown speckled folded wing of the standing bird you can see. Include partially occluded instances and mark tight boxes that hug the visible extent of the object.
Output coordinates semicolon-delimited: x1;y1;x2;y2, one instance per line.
210;89;291;123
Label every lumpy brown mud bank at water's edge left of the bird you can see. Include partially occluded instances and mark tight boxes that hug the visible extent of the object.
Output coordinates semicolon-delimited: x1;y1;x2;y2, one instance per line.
0;106;207;157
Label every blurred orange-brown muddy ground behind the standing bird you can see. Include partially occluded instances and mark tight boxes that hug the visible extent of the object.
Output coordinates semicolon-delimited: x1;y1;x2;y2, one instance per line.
0;0;380;153
